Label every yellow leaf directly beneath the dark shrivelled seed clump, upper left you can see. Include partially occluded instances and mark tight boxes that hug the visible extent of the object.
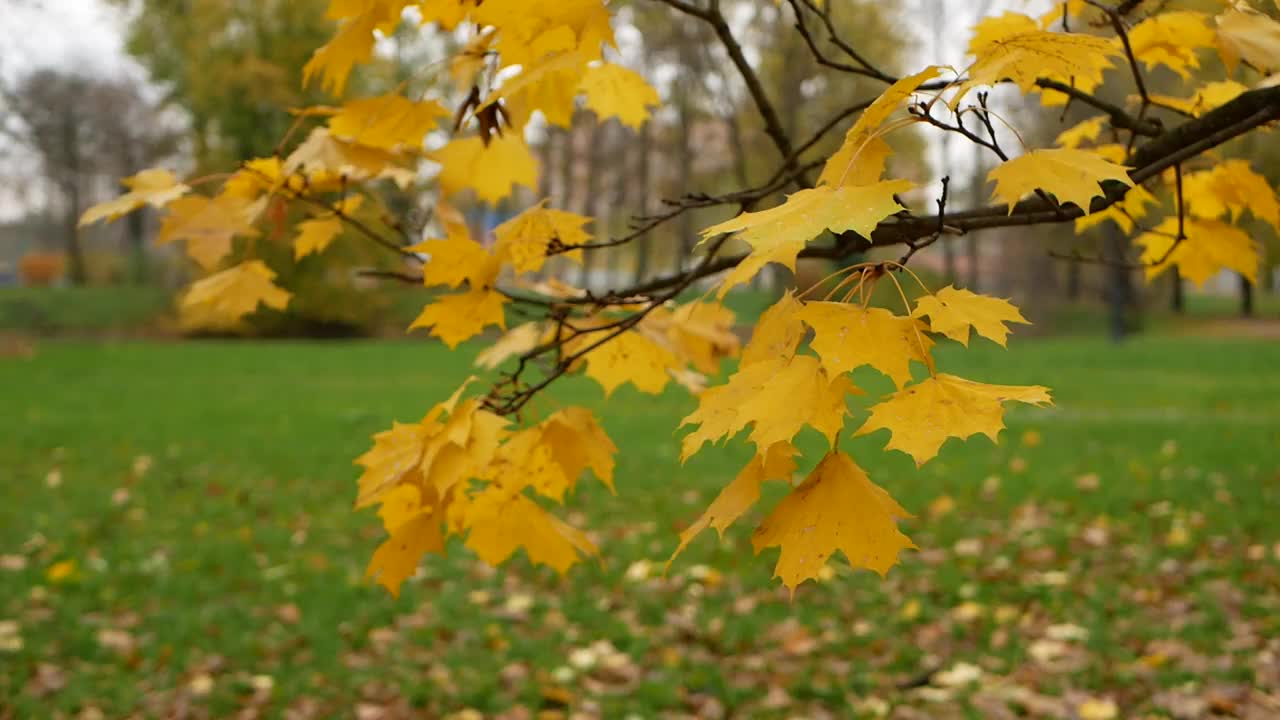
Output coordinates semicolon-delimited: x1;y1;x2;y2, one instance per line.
430;133;538;202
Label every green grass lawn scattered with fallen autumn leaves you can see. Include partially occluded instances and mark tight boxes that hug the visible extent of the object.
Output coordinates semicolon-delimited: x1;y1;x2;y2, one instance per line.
0;338;1280;717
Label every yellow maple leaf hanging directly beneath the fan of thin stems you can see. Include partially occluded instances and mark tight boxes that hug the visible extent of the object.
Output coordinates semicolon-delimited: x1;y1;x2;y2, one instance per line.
800;302;933;387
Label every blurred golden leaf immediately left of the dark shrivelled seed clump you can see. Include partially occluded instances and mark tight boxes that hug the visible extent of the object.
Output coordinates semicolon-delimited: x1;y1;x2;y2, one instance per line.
329;92;449;150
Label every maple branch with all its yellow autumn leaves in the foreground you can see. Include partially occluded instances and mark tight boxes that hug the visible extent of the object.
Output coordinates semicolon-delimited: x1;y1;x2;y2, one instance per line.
82;0;1280;593
